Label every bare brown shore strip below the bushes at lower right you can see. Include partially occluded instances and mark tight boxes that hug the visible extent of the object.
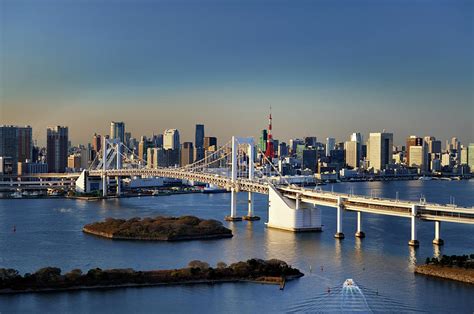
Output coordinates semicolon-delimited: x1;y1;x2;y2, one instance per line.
415;265;474;285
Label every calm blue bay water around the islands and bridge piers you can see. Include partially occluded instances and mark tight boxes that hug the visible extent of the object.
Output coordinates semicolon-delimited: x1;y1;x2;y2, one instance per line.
0;180;474;313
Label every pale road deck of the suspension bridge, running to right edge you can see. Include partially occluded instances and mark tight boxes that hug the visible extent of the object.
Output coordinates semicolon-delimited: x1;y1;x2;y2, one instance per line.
89;168;474;224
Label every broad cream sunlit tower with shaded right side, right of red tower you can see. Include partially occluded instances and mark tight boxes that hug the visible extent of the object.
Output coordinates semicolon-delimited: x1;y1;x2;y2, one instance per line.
368;132;393;171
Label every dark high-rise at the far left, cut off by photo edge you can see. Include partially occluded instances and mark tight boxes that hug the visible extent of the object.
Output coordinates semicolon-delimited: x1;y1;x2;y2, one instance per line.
0;125;18;174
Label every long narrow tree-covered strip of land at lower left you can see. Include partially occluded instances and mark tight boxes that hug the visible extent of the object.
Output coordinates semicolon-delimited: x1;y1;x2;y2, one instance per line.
0;259;303;294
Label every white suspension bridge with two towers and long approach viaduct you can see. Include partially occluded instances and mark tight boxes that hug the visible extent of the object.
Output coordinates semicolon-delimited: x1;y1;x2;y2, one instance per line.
3;137;474;247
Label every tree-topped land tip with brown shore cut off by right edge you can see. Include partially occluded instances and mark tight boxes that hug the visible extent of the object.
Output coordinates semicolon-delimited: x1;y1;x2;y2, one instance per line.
415;254;474;284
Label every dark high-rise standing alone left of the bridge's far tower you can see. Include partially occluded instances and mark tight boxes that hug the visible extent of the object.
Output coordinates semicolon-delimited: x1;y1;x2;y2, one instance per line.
46;126;69;172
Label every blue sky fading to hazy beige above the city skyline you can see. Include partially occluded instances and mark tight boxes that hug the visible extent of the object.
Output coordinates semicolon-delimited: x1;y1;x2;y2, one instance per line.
0;0;474;144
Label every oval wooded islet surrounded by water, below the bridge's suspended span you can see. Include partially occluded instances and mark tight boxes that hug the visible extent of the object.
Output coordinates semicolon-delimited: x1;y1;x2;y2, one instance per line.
82;216;232;241
